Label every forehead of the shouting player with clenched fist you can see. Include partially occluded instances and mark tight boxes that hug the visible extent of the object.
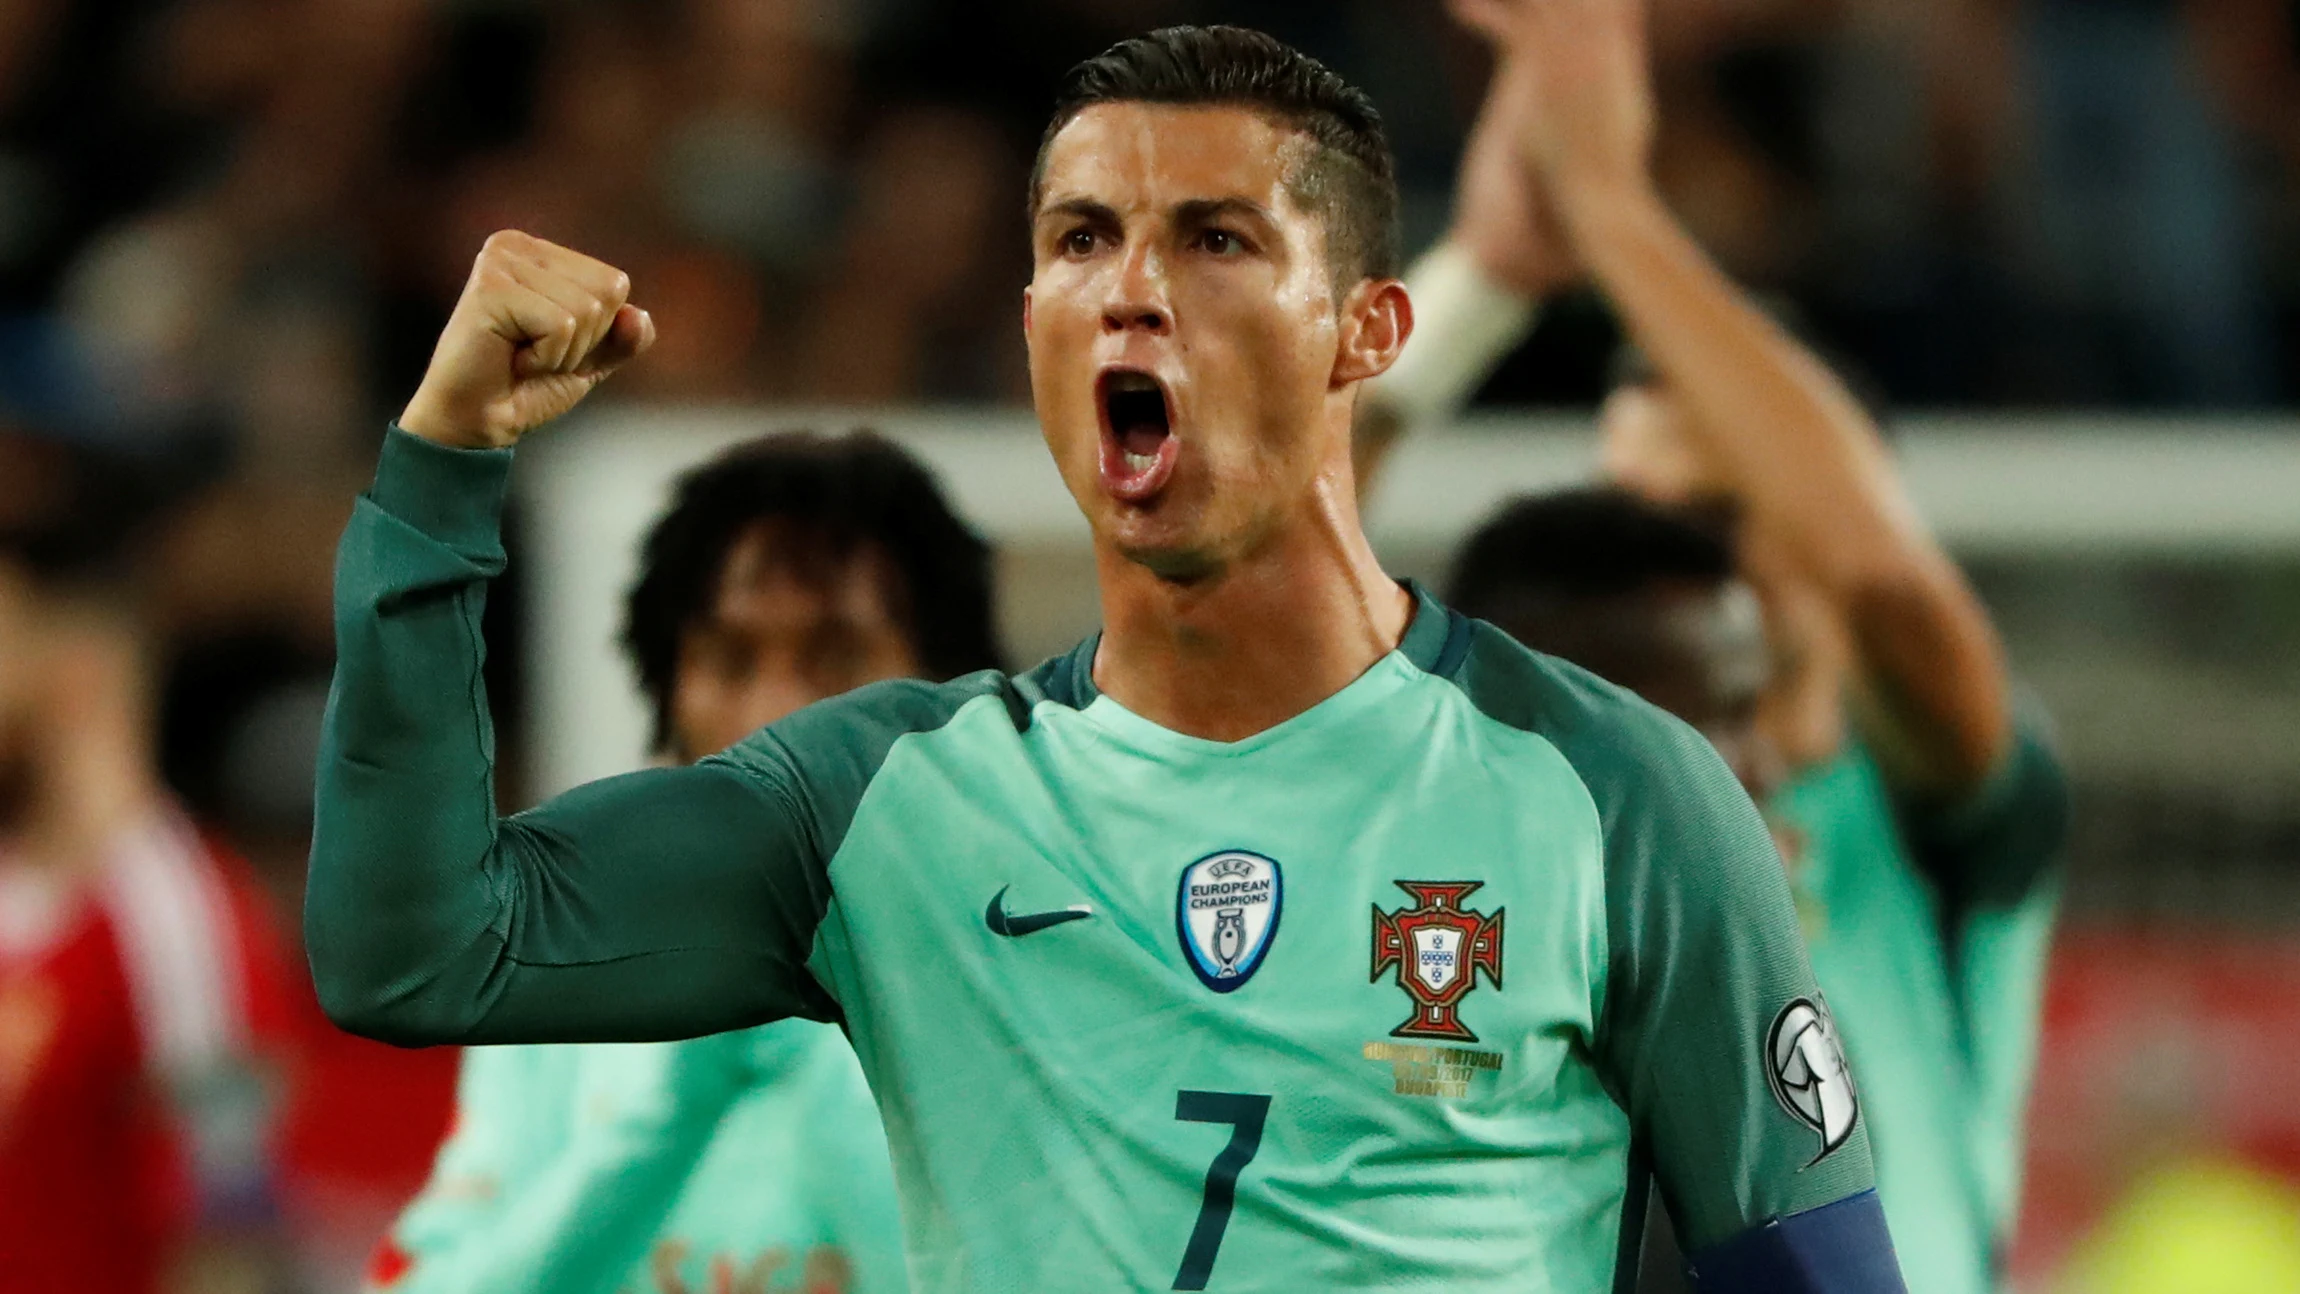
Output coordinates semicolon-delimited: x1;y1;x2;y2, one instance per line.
1037;103;1311;211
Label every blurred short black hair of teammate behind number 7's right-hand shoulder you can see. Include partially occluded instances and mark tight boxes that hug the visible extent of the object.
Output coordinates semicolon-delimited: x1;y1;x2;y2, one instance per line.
1447;485;1737;625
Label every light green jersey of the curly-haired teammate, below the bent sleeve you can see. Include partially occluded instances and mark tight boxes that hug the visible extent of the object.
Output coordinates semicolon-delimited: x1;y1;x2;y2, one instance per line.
372;1020;906;1294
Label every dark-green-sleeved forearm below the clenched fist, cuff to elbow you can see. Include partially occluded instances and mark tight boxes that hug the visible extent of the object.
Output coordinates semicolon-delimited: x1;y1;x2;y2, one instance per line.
304;430;511;1041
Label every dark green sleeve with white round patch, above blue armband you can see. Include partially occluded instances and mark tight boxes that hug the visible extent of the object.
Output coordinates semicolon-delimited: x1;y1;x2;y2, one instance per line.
1463;625;1875;1253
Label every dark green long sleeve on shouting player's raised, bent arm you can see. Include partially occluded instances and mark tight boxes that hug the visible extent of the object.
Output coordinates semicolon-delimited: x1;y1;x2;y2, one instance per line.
304;428;837;1046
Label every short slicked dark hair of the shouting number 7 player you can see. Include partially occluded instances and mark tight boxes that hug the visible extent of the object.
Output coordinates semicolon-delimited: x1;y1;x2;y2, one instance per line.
1030;28;1401;287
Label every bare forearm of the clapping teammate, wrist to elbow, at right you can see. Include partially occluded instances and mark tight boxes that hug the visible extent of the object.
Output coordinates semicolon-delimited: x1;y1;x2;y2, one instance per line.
1566;186;2008;788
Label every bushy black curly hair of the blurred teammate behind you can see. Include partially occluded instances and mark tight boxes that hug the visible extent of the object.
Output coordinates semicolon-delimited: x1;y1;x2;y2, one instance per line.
623;432;1005;747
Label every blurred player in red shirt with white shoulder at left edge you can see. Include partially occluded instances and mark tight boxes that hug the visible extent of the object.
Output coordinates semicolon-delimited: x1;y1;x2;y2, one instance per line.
0;554;285;1294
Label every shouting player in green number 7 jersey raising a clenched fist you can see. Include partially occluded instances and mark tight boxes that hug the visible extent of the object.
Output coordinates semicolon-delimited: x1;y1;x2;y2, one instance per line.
306;28;1900;1292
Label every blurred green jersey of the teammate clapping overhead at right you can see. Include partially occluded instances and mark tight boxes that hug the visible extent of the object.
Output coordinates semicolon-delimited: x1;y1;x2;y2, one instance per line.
1771;717;2068;1294
